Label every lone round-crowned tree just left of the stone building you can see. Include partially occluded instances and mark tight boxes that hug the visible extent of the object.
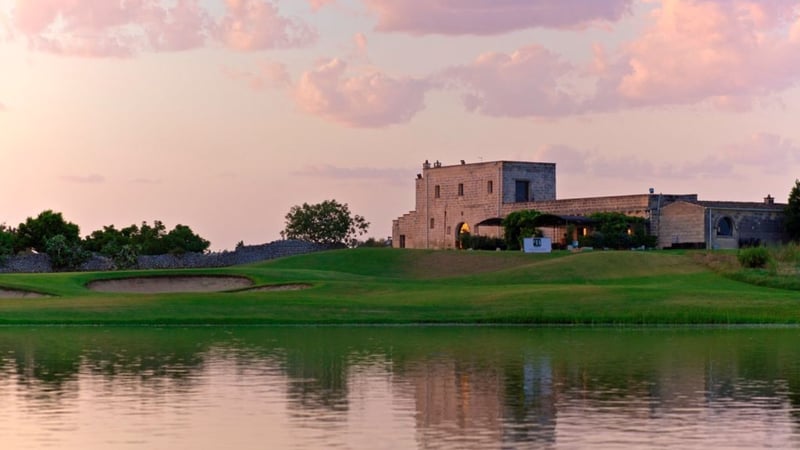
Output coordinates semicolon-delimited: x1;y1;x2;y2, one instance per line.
281;200;369;245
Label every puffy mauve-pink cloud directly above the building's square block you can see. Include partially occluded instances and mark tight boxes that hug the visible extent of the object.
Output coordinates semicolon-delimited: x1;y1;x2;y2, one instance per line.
443;45;577;117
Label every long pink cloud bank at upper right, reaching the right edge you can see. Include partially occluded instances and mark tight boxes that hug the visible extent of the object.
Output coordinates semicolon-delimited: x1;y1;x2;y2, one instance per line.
438;0;800;118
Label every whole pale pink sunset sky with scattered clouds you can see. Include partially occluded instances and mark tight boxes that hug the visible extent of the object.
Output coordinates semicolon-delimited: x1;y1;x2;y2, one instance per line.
0;0;800;250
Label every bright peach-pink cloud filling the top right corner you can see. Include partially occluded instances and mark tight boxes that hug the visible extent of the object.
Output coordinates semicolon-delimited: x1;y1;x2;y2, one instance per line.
592;0;800;111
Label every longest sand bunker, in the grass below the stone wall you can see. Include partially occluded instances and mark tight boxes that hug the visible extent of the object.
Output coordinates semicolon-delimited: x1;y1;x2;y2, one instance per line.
88;276;253;294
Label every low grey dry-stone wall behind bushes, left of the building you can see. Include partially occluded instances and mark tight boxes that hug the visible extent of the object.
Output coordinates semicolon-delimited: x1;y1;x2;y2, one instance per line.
0;240;329;273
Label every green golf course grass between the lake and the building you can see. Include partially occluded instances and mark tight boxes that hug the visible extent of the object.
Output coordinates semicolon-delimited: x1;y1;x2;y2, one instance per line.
0;249;800;325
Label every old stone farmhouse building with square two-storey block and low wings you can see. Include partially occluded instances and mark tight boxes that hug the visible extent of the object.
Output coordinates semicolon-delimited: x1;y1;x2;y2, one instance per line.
392;161;785;249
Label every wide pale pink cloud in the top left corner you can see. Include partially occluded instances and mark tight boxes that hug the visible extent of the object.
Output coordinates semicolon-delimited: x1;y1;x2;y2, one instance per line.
13;0;206;57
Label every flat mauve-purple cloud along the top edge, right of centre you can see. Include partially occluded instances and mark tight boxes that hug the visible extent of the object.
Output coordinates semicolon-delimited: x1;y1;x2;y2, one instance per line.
364;0;632;35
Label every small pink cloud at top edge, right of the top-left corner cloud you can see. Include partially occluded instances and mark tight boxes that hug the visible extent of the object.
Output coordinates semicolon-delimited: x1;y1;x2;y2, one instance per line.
214;0;317;50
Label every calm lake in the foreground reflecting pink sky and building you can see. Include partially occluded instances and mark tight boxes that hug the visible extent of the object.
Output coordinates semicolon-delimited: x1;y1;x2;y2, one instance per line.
0;327;800;449
